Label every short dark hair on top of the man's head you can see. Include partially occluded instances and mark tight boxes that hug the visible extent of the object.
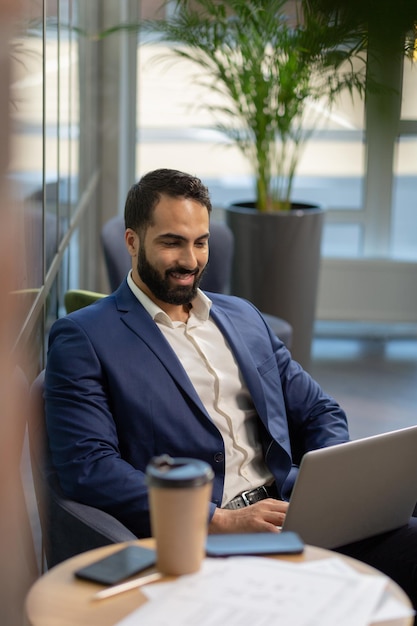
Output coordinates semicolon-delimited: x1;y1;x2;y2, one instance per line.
125;169;212;233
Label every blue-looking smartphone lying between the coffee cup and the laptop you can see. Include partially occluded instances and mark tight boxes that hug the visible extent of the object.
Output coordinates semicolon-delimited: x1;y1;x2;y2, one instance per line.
206;531;304;556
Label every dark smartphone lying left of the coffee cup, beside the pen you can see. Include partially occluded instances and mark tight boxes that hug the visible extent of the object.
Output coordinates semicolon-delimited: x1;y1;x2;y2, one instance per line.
74;545;156;585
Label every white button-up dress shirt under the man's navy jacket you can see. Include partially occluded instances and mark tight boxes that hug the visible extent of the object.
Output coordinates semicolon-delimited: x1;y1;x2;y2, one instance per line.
127;272;272;506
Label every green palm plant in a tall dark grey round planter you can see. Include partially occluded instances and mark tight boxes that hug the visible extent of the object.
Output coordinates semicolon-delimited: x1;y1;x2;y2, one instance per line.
142;0;366;367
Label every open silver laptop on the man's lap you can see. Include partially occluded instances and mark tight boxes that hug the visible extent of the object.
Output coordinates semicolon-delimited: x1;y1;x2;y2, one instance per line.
283;426;417;548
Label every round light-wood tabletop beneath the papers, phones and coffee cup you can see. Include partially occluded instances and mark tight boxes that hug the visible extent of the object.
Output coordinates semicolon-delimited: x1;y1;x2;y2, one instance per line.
25;539;413;626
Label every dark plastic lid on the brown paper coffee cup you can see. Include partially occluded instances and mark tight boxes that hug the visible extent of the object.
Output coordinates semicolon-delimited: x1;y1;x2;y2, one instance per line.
146;454;214;488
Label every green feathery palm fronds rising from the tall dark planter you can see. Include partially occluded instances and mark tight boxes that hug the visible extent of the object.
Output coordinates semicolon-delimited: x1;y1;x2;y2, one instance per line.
141;0;410;210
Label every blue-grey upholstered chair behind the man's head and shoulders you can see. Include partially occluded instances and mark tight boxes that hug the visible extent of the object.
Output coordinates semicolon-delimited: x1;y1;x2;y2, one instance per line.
101;215;292;348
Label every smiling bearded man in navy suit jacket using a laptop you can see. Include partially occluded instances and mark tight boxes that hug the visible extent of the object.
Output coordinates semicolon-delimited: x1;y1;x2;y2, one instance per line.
45;170;417;604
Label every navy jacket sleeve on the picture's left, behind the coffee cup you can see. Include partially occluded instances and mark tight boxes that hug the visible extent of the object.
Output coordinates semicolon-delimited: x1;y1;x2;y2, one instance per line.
45;318;150;537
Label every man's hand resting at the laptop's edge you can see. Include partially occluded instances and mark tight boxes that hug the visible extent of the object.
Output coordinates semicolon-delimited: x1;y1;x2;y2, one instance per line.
208;498;288;534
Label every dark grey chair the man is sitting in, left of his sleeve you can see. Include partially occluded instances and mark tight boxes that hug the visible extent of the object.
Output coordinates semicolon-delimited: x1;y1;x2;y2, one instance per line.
28;372;136;568
